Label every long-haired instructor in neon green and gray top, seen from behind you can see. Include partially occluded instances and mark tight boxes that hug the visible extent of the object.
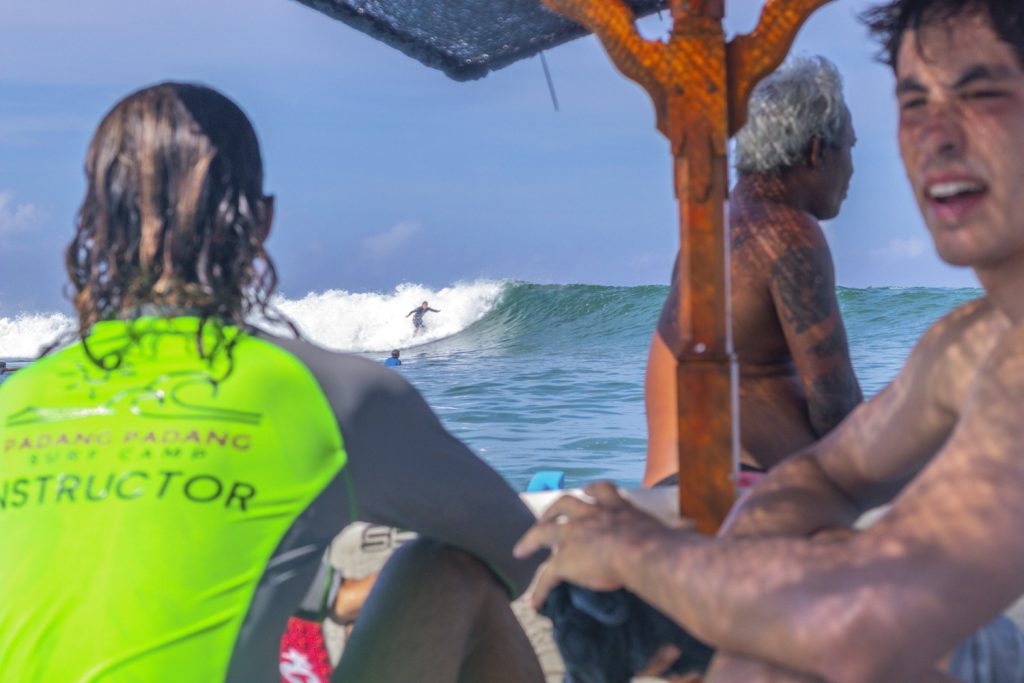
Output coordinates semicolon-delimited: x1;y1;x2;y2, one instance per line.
0;83;540;683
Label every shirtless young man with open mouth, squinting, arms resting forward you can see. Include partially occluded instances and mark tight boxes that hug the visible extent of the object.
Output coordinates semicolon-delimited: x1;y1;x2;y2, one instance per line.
516;0;1024;683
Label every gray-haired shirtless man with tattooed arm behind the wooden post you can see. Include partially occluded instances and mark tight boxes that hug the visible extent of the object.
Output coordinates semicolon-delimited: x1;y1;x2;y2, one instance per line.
643;57;863;485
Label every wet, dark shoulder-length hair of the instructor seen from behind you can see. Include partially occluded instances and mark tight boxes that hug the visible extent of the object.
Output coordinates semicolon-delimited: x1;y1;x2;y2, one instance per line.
66;83;295;367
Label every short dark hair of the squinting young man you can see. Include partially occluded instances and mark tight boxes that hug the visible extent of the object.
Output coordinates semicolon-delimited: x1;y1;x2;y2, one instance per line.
860;0;1024;70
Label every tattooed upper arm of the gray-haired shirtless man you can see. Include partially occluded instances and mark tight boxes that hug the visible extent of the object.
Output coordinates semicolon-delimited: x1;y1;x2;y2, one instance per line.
770;216;863;437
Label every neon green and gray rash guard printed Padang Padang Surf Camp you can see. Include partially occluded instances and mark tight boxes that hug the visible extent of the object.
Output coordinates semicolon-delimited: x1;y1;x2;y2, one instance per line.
0;317;534;683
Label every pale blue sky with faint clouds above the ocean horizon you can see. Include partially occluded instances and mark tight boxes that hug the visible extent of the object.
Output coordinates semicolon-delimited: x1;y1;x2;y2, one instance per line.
0;0;975;315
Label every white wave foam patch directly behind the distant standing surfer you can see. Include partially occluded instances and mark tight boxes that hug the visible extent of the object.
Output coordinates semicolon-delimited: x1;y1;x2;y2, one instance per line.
274;280;506;352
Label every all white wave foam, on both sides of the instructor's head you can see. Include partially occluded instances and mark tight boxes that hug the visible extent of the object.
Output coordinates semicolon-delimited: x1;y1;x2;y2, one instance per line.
0;280;506;358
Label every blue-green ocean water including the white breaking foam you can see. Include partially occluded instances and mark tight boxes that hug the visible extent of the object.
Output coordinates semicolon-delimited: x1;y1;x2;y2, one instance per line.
0;281;981;487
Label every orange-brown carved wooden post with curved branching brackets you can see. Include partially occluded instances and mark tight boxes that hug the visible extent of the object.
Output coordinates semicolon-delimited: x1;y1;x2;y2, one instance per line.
543;0;830;533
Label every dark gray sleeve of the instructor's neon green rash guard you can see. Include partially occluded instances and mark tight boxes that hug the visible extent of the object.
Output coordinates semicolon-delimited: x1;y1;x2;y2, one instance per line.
268;338;539;595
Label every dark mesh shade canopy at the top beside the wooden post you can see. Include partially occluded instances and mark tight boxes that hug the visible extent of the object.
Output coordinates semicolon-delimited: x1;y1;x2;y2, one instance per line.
299;0;667;81
